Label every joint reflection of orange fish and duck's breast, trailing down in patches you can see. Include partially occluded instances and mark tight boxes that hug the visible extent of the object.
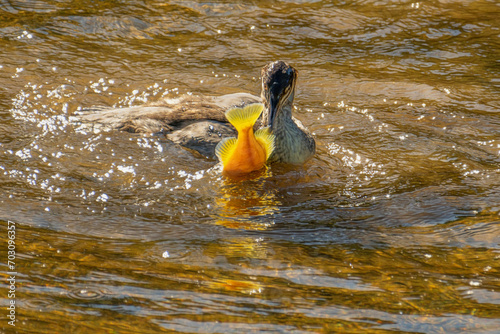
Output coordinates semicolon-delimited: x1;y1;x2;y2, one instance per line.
205;164;309;295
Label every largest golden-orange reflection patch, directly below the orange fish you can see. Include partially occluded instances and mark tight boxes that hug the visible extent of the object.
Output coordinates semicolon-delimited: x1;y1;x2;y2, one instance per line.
216;168;281;230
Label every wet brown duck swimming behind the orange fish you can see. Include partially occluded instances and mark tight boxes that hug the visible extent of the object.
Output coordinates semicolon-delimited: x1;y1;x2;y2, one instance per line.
76;60;316;165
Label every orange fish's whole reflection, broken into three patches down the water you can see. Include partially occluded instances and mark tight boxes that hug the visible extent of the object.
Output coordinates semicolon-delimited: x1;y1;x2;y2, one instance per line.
205;168;281;295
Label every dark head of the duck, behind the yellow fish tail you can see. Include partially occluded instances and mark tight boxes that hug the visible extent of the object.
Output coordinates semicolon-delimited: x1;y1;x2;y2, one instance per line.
261;60;297;129
